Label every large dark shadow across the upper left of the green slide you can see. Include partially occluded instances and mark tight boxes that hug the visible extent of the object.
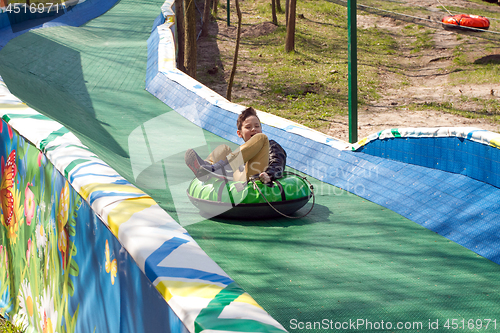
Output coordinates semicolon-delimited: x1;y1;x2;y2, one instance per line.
0;32;128;157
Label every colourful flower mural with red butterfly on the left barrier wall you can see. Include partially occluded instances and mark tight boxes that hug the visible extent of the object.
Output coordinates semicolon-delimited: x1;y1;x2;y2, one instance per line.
0;121;82;333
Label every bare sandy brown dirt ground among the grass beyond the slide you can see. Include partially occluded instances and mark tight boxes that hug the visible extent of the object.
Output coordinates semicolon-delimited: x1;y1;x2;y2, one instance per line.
198;0;500;141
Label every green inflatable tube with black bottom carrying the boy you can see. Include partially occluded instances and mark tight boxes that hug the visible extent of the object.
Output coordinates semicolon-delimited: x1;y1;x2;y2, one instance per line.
187;174;312;220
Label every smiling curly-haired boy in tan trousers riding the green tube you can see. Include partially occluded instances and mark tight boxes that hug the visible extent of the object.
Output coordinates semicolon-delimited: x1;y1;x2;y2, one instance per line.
184;107;286;183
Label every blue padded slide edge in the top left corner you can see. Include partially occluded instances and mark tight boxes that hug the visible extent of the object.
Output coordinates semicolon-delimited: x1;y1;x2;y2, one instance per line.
0;0;119;50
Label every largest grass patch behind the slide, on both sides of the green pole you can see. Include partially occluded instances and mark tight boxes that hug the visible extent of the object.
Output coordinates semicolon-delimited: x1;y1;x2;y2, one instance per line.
227;1;398;130
